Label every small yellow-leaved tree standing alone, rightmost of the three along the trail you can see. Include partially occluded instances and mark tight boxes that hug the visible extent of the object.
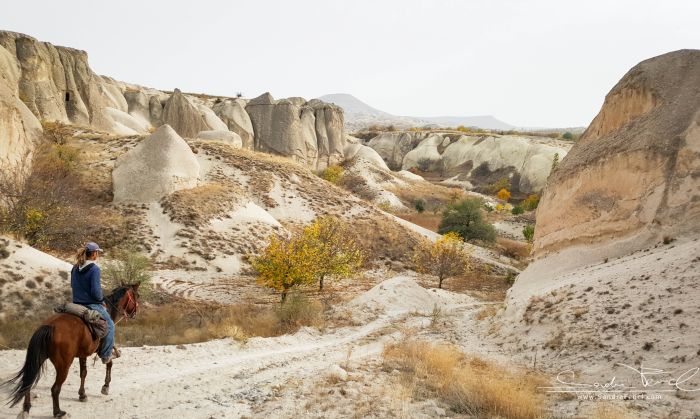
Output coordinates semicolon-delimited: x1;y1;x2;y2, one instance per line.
414;232;470;288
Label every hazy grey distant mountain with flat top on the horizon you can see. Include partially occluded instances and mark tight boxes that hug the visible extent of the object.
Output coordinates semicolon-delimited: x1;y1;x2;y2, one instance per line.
318;93;514;131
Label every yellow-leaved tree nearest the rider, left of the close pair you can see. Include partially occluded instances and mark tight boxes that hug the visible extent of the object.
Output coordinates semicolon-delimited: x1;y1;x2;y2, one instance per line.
251;235;318;303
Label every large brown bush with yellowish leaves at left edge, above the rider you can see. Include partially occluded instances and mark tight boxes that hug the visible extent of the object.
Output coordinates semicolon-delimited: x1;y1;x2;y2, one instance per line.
0;137;128;253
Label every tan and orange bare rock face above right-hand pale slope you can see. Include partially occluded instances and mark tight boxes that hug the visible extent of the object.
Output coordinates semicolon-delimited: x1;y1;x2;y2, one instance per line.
534;50;700;256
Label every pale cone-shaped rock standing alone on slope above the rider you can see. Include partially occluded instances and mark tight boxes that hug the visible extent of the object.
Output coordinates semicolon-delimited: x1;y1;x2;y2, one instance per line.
112;125;200;203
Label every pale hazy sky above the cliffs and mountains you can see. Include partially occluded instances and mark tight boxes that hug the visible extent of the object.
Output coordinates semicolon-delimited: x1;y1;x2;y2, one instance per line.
0;0;700;127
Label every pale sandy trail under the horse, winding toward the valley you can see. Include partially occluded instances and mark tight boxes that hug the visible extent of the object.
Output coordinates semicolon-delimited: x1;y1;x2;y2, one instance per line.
0;296;492;418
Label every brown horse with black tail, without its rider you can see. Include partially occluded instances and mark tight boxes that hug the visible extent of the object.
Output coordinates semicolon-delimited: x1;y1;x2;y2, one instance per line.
5;284;139;418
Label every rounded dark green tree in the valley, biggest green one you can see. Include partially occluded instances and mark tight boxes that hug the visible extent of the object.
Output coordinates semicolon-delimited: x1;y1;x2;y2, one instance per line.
438;199;496;242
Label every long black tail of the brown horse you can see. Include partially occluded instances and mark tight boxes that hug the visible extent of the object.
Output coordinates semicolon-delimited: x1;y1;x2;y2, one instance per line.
5;325;53;407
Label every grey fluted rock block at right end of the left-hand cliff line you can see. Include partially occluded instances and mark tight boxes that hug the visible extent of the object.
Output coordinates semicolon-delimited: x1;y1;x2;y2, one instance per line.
246;93;345;170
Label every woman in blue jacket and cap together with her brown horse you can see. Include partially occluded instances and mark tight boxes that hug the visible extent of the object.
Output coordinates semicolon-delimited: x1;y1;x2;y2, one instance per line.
4;242;139;418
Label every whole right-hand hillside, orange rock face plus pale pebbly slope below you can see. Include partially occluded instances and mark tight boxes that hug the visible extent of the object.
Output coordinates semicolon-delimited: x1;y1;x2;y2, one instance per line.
498;50;700;406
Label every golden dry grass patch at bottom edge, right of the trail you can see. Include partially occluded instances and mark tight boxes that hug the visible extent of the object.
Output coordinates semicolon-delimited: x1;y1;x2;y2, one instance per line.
383;340;545;419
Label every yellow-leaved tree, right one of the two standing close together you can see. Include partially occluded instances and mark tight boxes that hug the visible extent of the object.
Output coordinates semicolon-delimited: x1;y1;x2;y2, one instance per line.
302;217;364;291
